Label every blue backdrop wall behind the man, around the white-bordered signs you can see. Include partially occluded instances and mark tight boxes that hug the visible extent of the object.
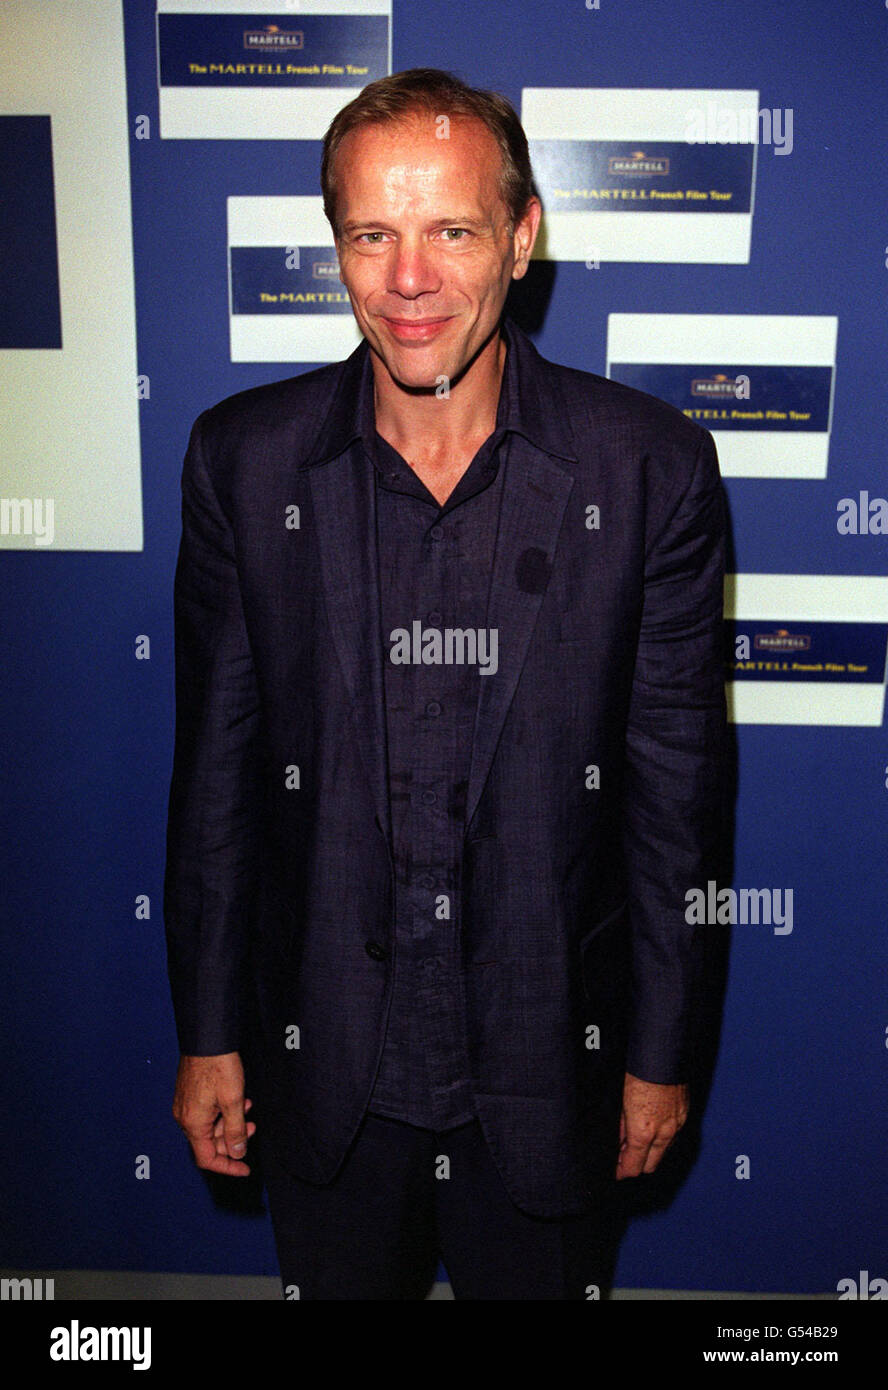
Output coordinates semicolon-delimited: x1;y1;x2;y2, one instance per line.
0;0;888;1293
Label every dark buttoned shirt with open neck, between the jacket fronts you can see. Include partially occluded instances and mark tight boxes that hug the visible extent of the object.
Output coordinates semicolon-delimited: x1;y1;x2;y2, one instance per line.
360;333;516;1130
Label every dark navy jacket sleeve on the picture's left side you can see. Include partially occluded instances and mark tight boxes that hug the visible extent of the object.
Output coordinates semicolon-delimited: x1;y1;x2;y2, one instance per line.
164;411;260;1056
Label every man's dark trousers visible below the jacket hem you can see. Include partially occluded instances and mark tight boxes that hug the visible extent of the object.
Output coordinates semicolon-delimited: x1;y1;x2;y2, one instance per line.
257;1115;616;1300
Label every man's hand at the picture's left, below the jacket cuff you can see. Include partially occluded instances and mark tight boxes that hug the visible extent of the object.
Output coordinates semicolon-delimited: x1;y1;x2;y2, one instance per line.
172;1052;256;1177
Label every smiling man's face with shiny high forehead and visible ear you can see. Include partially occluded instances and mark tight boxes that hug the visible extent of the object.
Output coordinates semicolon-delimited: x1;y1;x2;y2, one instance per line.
336;117;541;388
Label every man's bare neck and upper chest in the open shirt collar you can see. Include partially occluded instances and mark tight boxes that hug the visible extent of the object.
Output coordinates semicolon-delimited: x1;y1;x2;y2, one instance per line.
372;319;506;468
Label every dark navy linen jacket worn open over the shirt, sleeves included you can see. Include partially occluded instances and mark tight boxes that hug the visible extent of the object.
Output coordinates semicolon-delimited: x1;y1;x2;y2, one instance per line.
164;320;725;1216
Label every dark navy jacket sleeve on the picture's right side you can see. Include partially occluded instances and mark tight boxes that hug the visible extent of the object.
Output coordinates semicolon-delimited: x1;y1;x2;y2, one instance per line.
623;431;727;1084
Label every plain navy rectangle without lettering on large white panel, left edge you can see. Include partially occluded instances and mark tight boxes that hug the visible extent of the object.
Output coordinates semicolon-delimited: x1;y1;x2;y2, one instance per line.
0;115;61;348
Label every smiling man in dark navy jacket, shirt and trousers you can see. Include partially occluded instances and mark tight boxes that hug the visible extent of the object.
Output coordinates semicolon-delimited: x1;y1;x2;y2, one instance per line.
164;70;724;1298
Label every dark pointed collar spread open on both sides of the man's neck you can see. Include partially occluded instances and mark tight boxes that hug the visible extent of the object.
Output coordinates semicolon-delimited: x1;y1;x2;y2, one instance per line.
303;316;577;468
